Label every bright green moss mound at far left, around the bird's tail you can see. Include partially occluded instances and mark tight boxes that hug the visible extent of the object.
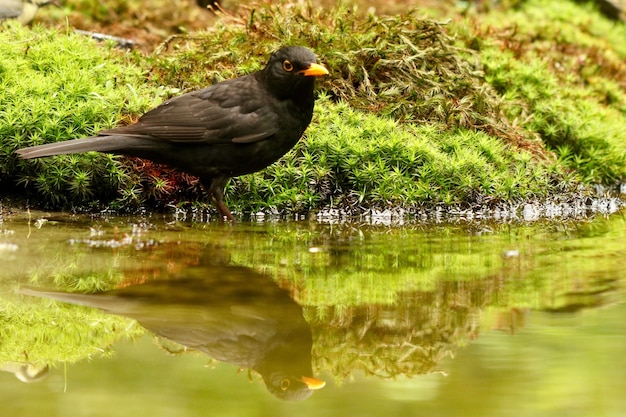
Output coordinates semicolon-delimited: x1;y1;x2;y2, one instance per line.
0;24;162;207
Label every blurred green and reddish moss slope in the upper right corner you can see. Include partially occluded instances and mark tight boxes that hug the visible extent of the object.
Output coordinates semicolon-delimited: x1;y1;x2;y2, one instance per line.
460;0;626;184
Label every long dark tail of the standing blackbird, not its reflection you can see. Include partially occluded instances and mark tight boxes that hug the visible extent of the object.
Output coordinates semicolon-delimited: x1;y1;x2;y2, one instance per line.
16;135;132;159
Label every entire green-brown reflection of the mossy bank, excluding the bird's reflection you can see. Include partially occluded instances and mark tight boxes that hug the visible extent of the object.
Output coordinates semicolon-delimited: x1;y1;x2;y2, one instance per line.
0;217;626;380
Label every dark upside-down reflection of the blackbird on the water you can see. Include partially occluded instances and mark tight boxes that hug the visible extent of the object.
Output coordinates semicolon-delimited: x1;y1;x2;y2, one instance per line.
20;265;324;400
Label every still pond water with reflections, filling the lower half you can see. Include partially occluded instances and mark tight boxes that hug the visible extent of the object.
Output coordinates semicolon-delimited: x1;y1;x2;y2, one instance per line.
0;213;626;417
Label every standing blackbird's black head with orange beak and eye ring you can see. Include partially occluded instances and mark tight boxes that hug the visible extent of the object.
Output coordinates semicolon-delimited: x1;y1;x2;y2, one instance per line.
263;46;328;99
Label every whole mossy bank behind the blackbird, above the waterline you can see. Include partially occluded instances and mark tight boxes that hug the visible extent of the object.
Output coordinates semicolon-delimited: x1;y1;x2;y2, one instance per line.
0;0;626;213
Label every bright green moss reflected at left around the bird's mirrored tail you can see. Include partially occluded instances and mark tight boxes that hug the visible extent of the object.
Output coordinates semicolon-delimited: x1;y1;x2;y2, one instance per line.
0;240;139;366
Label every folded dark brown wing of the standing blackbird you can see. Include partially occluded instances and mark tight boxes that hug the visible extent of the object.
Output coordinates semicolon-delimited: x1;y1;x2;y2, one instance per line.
99;76;279;143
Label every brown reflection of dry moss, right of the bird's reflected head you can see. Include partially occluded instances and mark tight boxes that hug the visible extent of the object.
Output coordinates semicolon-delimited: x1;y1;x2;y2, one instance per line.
308;280;499;381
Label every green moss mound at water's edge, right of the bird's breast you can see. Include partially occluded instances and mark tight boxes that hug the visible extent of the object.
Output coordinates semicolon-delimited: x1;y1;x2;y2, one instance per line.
228;97;554;212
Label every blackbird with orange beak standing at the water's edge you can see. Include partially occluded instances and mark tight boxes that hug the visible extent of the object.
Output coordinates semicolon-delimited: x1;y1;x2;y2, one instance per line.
17;46;328;221
